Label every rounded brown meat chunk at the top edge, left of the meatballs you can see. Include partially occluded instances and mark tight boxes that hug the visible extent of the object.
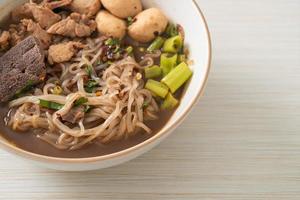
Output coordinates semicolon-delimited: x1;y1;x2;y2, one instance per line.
69;0;101;17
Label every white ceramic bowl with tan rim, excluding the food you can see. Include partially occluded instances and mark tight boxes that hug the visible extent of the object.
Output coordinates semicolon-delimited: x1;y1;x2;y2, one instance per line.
0;0;211;171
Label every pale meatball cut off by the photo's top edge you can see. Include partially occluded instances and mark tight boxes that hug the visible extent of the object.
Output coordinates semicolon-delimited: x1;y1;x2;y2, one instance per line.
102;0;142;18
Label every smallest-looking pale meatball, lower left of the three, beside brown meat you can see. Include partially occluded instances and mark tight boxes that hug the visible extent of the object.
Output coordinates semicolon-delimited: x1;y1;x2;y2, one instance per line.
96;11;127;39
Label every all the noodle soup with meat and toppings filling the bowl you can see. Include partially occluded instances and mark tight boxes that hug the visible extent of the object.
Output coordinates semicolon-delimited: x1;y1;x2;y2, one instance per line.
0;0;192;158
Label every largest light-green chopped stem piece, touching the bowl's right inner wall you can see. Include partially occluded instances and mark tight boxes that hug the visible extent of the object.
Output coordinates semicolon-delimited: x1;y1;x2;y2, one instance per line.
161;62;193;93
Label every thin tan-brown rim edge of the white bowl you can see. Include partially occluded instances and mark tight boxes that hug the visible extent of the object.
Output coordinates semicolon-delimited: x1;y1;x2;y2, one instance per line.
0;0;212;164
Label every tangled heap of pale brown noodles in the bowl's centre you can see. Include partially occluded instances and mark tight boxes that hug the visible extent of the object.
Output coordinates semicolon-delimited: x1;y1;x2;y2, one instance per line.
8;39;158;150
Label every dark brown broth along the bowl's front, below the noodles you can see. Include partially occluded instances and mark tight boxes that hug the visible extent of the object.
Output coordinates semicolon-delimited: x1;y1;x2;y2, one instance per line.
0;106;177;158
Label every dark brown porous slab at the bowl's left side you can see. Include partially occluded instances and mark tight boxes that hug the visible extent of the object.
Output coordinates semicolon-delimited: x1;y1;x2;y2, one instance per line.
0;36;46;102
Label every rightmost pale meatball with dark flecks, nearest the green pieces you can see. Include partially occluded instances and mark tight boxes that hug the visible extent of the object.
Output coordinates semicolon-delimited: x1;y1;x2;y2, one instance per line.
128;8;168;42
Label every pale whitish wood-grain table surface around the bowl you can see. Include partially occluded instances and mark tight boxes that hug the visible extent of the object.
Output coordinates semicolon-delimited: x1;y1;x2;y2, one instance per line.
0;0;300;200
